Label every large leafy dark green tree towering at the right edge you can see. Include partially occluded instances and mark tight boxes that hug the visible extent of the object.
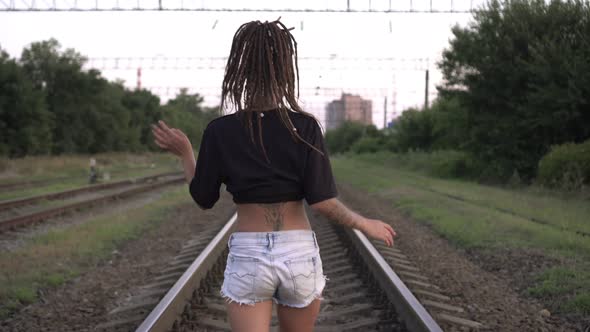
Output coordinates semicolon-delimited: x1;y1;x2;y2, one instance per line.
438;0;590;179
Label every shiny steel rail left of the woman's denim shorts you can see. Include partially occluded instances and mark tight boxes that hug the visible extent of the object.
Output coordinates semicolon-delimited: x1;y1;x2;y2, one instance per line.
136;213;238;332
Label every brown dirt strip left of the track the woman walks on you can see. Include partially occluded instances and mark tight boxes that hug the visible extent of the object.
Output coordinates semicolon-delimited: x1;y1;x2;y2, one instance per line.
0;194;234;332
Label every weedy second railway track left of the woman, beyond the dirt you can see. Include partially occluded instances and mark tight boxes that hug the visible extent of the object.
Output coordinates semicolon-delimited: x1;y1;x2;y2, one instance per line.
0;173;184;233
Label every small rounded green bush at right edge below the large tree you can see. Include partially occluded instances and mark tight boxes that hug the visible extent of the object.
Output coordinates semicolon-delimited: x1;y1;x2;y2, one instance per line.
537;140;590;190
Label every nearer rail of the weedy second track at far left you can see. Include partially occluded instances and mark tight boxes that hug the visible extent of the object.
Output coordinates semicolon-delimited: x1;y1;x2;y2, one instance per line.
0;177;184;233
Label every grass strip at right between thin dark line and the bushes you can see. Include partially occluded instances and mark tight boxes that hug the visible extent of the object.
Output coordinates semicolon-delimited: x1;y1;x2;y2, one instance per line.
335;153;590;241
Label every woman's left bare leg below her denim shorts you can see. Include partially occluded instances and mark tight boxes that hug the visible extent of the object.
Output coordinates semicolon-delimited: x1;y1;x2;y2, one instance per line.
226;301;272;332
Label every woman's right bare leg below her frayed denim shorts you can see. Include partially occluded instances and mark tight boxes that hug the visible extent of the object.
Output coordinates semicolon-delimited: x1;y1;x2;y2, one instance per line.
277;299;321;332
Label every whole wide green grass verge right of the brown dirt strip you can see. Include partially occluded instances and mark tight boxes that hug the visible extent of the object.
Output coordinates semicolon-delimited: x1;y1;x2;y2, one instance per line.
332;156;590;314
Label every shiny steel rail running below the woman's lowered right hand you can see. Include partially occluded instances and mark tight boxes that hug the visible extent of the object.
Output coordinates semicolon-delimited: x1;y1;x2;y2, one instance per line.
345;228;442;332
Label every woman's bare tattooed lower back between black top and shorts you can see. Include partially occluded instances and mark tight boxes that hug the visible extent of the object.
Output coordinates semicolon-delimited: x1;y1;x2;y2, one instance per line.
237;200;311;232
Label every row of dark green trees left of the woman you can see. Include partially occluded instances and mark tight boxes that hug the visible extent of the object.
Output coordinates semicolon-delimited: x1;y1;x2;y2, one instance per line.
0;39;218;158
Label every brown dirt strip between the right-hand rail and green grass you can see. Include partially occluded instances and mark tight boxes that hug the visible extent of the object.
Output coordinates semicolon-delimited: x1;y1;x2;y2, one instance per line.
339;184;581;332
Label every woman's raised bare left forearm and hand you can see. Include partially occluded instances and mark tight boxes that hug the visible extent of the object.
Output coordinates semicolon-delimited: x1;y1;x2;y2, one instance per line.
152;120;196;183
